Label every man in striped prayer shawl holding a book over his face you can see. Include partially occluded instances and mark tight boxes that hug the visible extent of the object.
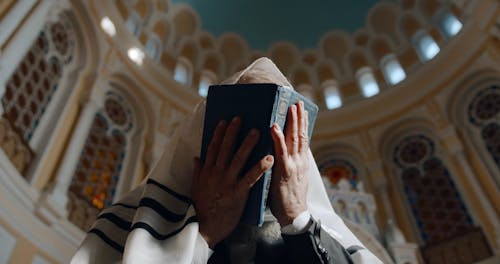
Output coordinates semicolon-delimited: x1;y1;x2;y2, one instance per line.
72;58;380;263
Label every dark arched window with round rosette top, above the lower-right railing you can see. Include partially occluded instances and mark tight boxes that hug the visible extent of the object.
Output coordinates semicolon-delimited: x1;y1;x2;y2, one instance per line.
393;135;472;244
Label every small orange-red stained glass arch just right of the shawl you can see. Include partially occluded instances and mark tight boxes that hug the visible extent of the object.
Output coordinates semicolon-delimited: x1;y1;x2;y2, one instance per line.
319;159;359;188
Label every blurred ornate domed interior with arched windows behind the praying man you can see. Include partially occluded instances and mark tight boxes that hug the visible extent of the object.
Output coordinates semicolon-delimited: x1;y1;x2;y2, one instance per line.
0;0;500;264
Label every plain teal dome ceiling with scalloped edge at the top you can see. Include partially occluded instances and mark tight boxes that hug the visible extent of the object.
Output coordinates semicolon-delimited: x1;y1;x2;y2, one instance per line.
172;0;380;50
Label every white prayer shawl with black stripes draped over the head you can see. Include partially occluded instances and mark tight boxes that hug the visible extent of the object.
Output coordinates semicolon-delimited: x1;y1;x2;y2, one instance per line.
71;58;381;264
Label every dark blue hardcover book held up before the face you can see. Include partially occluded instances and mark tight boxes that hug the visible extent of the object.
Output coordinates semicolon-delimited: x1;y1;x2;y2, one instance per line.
200;84;318;226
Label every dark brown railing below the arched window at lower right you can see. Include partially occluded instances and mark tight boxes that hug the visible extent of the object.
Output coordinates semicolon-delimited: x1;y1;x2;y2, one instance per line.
421;228;493;264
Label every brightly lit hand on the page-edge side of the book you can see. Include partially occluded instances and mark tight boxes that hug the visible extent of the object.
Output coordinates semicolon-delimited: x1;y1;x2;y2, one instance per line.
271;102;309;226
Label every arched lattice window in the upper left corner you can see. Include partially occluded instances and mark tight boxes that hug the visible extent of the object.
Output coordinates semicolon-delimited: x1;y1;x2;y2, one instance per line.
1;17;76;173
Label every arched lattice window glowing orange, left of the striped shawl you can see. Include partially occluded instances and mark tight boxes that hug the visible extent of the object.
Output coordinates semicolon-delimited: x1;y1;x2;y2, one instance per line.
68;92;133;230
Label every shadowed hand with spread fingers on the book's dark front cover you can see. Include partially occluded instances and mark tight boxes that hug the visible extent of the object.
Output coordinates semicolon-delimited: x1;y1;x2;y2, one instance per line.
191;117;274;248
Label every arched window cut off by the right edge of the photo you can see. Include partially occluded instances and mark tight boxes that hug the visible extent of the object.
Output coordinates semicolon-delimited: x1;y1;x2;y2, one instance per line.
468;84;500;188
